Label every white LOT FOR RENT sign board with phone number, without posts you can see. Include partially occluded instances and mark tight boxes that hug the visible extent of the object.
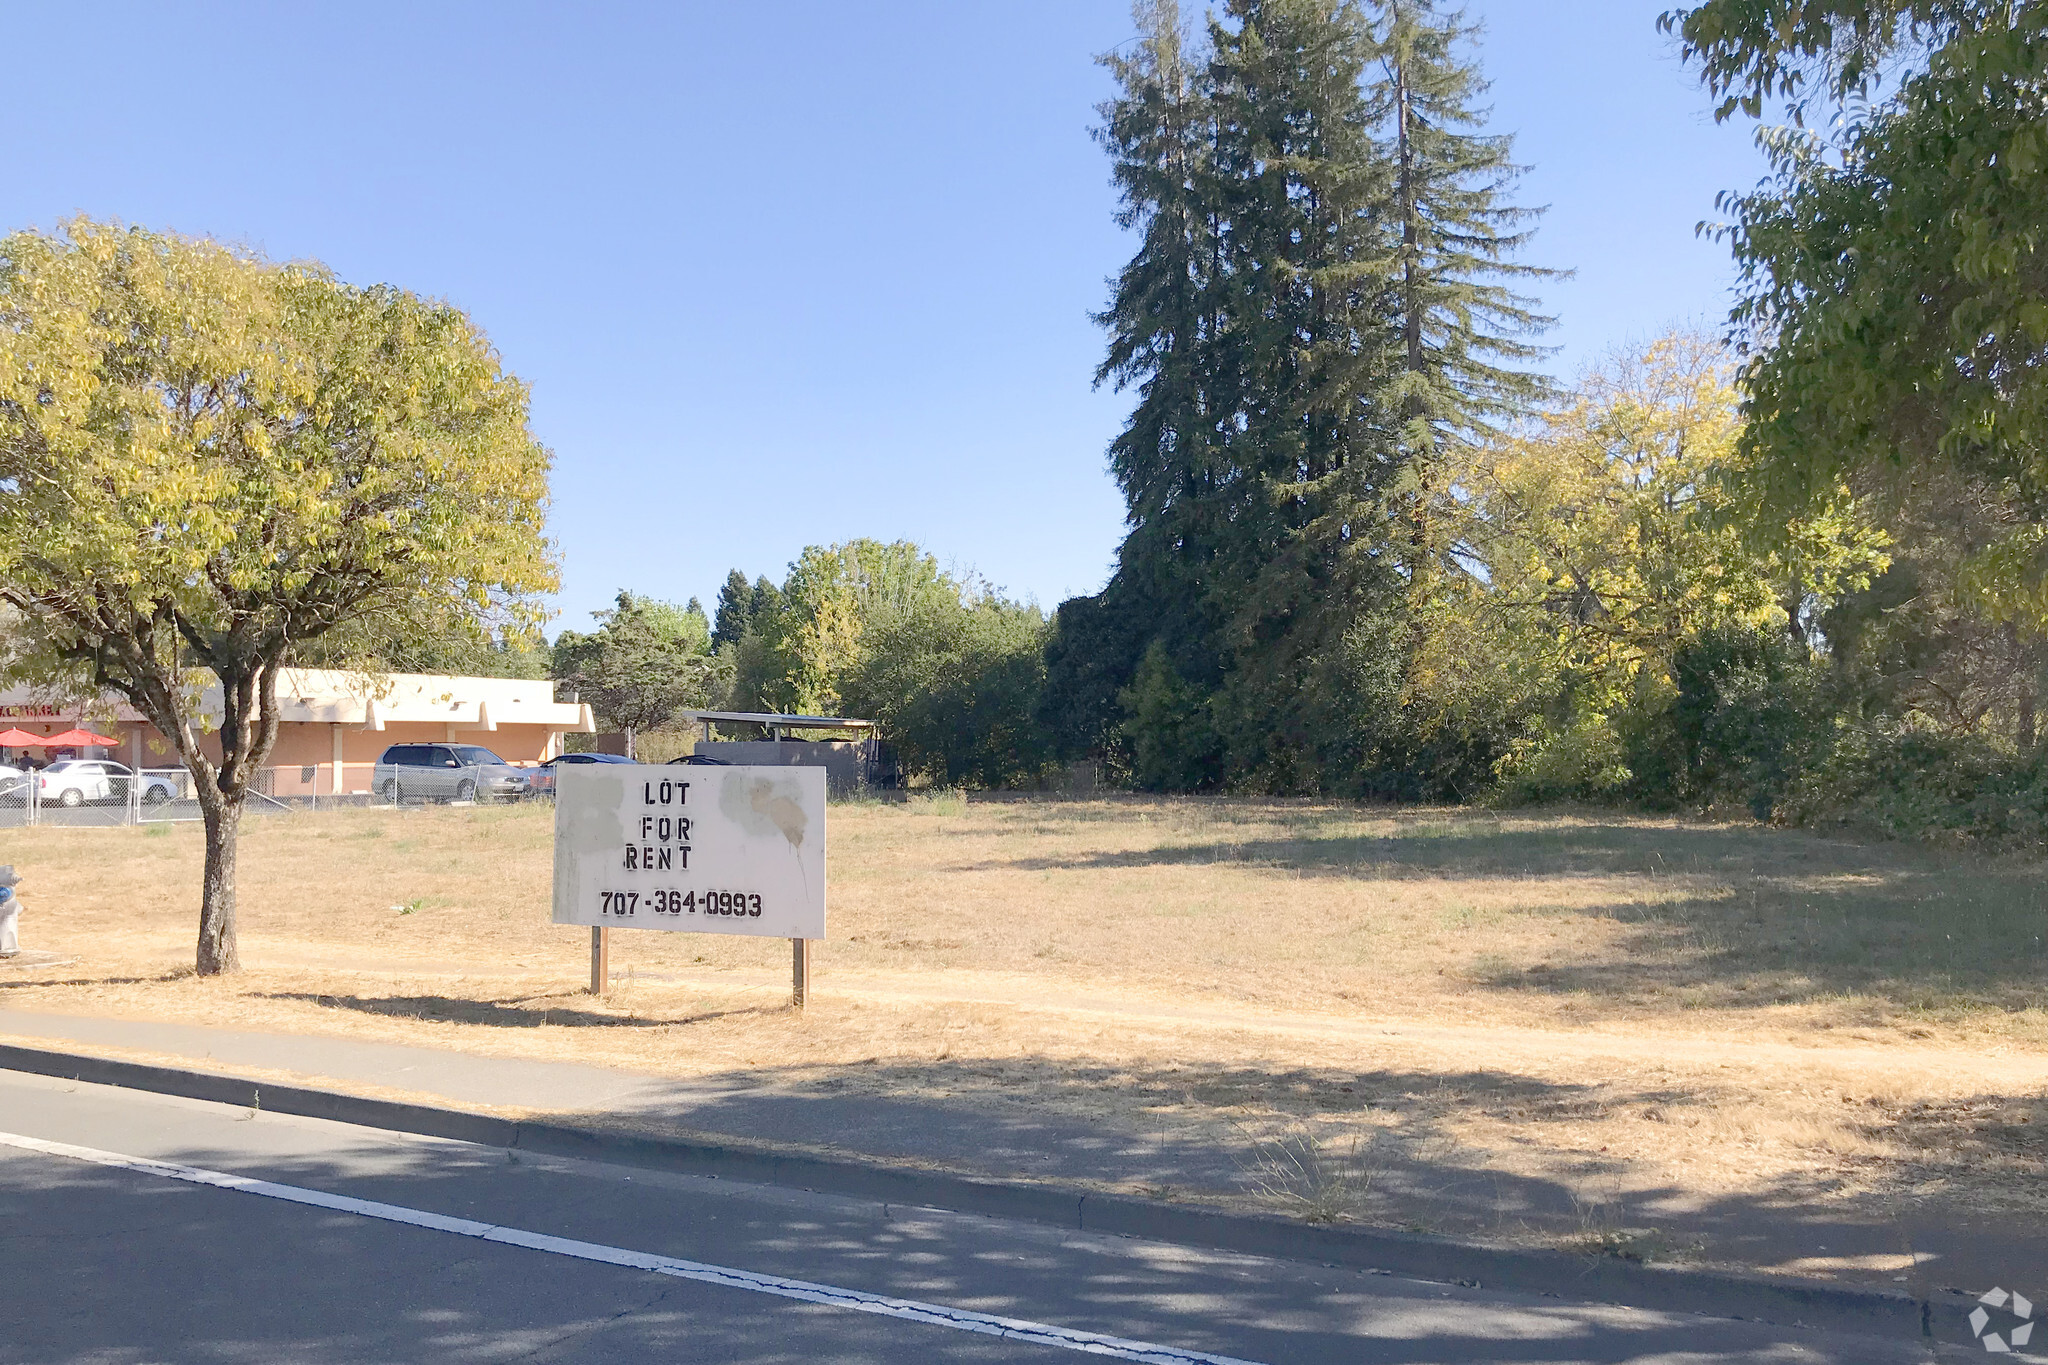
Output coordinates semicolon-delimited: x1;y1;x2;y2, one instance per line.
555;763;825;939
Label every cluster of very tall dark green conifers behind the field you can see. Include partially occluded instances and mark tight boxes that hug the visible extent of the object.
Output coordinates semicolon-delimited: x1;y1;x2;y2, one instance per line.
1081;0;1544;792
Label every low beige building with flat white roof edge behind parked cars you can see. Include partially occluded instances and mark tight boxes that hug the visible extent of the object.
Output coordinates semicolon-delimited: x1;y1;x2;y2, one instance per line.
0;669;596;796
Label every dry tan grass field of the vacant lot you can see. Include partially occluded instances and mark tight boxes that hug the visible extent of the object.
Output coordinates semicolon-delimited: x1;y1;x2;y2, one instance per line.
0;794;2048;1277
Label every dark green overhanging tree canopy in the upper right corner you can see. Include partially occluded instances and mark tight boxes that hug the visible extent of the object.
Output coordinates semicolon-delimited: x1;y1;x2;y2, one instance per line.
1663;0;2048;624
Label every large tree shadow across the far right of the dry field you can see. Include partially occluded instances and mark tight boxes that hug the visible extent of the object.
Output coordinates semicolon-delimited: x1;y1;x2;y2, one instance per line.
963;817;2048;1011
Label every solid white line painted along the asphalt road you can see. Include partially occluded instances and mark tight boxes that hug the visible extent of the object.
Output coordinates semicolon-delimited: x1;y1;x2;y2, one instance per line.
0;1134;1255;1365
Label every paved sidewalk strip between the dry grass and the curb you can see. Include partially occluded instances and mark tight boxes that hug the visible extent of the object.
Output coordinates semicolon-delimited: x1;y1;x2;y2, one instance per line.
0;1009;2048;1302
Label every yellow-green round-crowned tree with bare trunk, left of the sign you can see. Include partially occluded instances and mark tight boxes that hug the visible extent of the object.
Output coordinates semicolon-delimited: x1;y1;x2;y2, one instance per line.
0;219;555;976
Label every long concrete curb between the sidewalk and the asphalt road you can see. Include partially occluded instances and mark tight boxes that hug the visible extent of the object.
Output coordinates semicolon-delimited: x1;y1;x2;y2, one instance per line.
0;1044;1974;1345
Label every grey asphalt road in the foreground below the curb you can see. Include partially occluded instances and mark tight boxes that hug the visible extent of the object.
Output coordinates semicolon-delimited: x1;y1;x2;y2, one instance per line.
0;1072;1929;1365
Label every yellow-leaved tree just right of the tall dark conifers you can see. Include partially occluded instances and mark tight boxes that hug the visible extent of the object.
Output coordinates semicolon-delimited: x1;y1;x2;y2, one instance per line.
1409;334;1886;798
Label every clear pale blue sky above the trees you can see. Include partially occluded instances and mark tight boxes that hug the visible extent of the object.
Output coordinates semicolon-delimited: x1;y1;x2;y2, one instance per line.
0;0;1761;626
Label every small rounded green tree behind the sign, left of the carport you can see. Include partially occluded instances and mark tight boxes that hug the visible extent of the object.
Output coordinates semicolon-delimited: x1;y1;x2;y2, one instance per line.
553;591;721;757
